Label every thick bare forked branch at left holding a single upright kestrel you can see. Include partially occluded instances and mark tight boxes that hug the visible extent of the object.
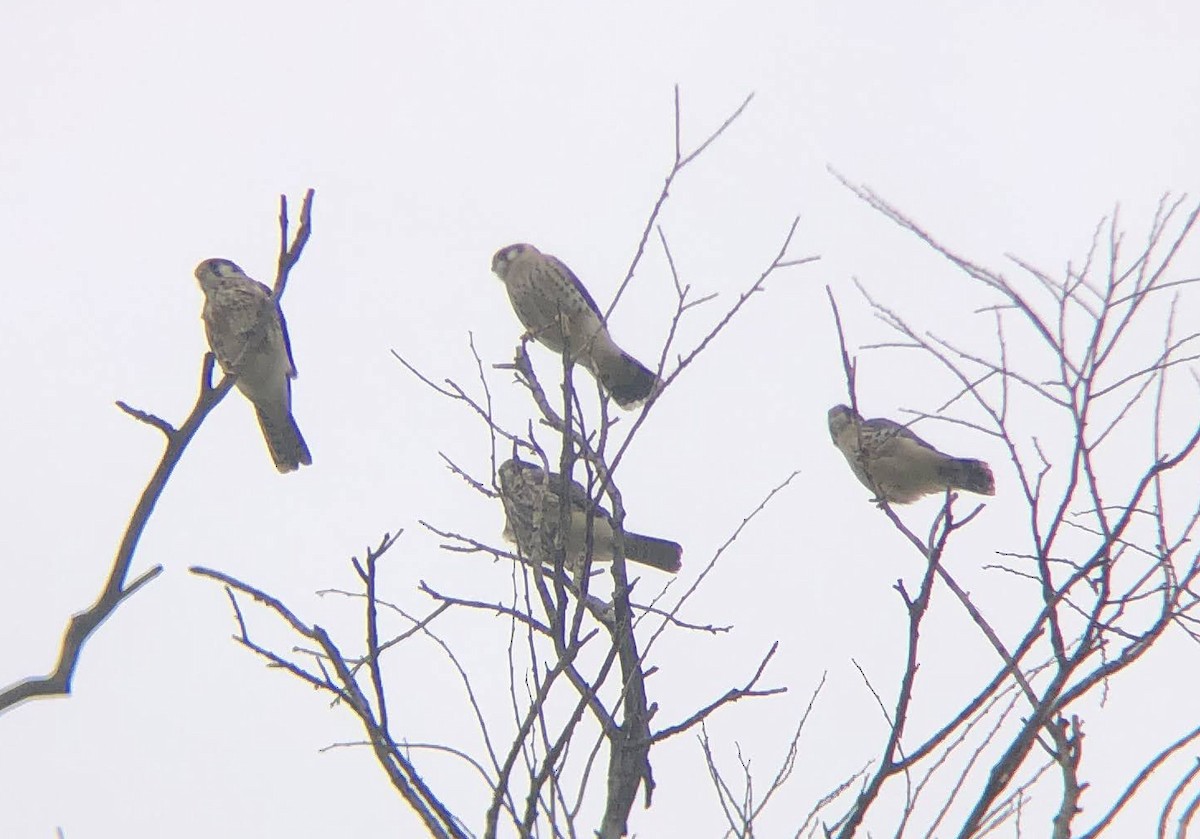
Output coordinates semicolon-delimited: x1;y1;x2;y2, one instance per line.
0;190;313;713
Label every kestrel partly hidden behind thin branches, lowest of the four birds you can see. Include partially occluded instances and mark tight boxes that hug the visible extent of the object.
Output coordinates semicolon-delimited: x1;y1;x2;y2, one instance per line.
499;460;683;574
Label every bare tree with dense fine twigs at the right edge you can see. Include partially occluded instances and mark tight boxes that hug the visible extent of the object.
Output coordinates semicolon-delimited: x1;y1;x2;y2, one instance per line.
782;179;1200;839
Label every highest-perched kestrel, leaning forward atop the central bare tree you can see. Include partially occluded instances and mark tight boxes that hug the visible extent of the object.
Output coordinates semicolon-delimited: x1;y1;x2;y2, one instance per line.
492;244;661;409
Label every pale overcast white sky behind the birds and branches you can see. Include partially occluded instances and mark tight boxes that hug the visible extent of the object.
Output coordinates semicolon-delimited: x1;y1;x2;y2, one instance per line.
0;0;1200;839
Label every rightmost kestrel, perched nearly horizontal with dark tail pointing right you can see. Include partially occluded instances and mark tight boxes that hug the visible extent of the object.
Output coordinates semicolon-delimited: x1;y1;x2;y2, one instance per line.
829;404;996;504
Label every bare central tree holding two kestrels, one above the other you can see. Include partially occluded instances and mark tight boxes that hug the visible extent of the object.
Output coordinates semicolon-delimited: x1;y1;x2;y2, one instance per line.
193;91;814;838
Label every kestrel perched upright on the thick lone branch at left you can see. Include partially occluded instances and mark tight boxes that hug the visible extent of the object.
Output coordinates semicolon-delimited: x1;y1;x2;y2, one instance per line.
196;259;312;472
